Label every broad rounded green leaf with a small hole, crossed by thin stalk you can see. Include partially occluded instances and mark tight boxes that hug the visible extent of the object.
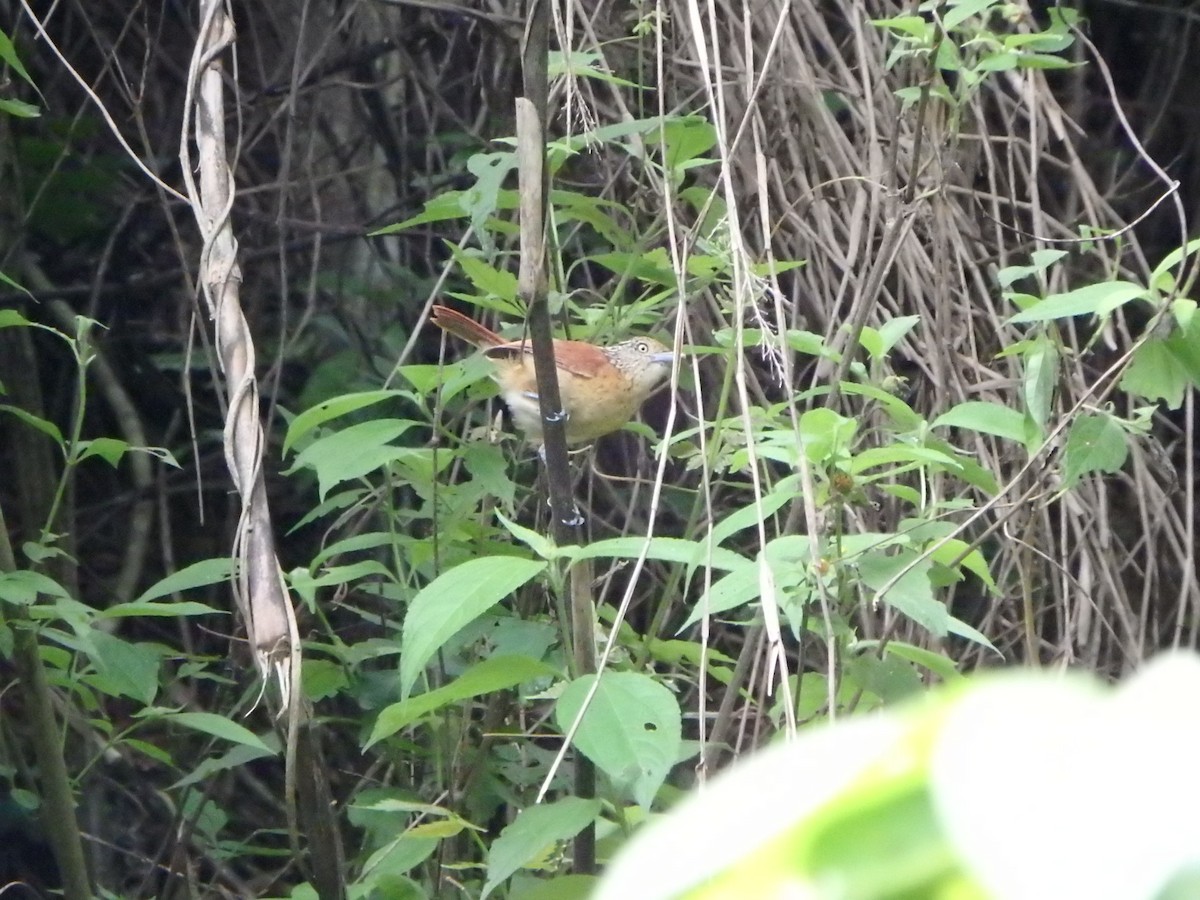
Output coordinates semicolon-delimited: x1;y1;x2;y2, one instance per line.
554;672;682;810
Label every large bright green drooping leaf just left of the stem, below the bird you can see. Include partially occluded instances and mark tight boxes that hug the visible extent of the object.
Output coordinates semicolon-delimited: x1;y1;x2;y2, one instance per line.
400;557;546;700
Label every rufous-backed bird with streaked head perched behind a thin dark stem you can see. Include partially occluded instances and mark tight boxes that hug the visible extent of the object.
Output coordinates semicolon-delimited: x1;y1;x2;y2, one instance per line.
430;306;674;444
